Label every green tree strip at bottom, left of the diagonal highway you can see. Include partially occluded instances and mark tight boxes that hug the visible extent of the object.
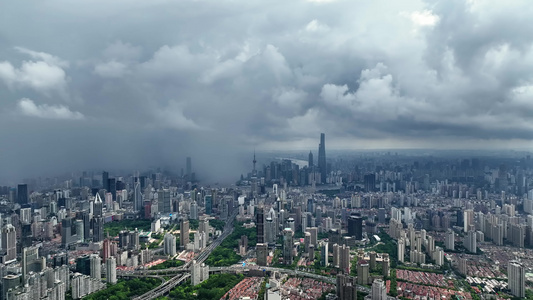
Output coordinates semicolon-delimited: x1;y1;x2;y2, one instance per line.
83;278;161;300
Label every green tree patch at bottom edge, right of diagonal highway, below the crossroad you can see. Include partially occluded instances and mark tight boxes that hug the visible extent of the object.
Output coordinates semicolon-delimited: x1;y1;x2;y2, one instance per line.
158;274;244;300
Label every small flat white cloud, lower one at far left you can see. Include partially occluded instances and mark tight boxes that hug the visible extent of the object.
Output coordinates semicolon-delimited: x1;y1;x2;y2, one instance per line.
17;98;85;120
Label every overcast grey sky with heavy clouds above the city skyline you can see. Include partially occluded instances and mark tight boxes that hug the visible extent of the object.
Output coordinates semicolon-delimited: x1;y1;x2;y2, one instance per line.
0;0;533;183
